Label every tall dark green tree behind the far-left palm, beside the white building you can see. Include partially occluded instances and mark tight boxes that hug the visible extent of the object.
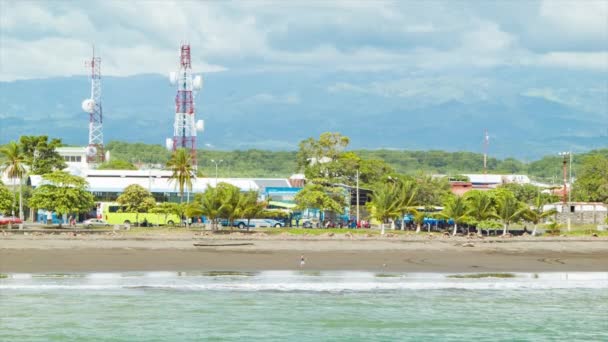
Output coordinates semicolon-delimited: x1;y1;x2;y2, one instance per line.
19;135;67;175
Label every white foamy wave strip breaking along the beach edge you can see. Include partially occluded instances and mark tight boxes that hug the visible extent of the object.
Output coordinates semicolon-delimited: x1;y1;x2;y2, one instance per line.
0;273;608;293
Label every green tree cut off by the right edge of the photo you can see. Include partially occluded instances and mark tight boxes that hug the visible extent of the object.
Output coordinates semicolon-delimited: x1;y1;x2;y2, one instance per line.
572;153;608;203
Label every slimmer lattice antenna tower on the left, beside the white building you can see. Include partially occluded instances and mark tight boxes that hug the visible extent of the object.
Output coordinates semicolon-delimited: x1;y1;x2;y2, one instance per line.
82;46;105;164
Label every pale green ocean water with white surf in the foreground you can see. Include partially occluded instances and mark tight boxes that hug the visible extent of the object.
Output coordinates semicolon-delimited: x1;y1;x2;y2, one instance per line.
0;271;608;341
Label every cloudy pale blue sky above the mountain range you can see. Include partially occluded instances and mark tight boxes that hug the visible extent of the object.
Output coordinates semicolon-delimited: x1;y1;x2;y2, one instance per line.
0;0;608;132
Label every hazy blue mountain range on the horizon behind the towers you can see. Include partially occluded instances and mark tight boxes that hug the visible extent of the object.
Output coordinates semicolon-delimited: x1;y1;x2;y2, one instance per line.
0;71;608;160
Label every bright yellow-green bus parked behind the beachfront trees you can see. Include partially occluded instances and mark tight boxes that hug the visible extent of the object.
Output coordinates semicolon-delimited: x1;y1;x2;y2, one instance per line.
97;202;181;226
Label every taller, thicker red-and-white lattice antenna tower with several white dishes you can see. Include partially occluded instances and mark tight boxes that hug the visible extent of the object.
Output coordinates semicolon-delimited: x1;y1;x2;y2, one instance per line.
166;44;203;167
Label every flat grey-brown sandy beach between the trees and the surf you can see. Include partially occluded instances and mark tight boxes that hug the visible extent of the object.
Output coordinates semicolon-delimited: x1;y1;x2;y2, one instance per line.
0;232;608;273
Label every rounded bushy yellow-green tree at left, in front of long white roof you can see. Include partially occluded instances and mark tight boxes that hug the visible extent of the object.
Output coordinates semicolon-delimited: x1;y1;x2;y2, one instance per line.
29;171;95;227
